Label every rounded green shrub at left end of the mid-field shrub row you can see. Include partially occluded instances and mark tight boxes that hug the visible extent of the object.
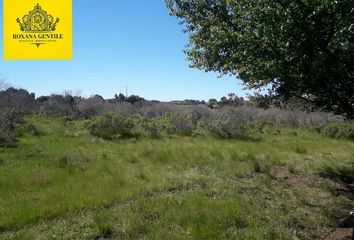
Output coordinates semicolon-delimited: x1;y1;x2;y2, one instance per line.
87;113;135;140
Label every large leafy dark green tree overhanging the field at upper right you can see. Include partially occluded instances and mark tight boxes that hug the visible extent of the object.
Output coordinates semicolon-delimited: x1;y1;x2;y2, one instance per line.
166;0;354;118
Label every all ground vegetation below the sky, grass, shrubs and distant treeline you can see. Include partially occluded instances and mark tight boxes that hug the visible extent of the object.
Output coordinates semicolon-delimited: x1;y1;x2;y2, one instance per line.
0;84;354;239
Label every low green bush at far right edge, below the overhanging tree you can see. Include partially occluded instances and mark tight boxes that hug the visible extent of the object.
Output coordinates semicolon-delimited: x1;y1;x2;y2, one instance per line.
320;123;354;140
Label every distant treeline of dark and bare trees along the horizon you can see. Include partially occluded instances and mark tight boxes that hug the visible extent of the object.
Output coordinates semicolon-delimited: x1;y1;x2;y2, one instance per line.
0;87;332;117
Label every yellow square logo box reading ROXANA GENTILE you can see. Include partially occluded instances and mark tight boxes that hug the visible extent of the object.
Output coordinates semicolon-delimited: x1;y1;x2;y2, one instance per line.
3;0;72;60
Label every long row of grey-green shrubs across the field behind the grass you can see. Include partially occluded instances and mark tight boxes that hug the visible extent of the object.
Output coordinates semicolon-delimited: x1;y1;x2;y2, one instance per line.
86;108;354;141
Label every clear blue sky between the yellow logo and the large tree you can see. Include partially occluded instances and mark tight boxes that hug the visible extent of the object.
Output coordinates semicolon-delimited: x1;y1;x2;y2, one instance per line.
0;0;249;101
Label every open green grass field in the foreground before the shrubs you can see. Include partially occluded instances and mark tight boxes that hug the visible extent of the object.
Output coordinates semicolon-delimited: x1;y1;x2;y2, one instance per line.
0;116;354;239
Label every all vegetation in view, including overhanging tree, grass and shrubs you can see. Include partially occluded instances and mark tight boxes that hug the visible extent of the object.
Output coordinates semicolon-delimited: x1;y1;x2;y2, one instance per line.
0;0;354;236
